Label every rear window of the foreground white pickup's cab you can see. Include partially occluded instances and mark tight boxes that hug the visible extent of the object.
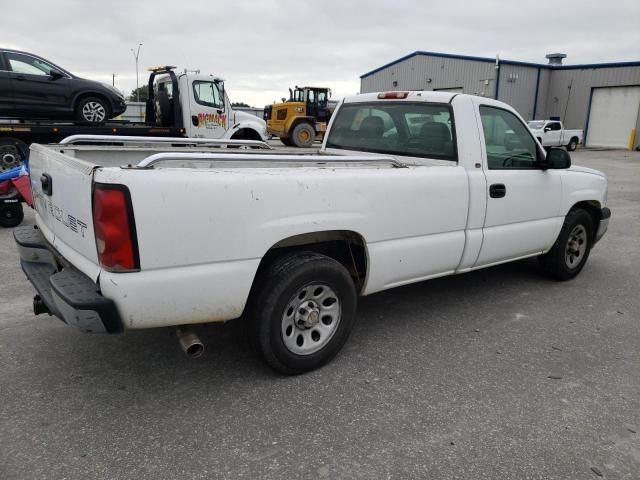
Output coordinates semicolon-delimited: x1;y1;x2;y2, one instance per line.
327;102;456;162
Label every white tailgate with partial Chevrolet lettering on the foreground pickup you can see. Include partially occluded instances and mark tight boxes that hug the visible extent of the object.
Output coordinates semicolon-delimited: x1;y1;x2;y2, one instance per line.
29;145;100;281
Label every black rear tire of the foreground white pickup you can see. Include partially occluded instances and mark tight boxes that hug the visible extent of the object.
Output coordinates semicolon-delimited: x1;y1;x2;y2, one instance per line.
247;252;357;375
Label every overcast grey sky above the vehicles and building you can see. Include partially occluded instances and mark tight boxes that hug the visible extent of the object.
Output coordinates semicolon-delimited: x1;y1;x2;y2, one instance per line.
0;0;640;107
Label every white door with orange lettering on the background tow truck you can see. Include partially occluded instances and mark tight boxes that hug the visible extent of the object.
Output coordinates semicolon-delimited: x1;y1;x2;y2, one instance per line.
186;78;229;138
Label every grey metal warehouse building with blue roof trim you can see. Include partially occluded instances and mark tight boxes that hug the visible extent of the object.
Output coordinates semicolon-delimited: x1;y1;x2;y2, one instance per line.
360;52;640;148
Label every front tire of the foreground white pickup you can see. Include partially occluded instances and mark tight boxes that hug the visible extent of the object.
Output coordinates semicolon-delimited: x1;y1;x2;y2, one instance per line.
538;208;594;280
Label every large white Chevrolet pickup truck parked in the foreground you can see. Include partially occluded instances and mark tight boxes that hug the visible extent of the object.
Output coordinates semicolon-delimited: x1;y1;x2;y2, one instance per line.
14;92;610;374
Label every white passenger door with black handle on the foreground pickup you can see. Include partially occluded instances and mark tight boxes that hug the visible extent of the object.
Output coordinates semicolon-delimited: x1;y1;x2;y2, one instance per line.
475;104;563;267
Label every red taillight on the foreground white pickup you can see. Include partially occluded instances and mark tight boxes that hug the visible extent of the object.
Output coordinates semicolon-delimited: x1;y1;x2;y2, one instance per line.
93;184;140;272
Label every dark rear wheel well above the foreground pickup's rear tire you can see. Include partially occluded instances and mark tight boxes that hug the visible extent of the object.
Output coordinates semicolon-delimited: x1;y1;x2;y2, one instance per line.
256;230;368;291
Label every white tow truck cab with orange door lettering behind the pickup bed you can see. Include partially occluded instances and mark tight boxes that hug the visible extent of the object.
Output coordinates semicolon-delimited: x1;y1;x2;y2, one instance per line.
146;66;267;140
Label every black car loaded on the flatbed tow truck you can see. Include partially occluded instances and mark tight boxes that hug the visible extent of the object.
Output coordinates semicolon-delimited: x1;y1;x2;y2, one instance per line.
0;49;127;123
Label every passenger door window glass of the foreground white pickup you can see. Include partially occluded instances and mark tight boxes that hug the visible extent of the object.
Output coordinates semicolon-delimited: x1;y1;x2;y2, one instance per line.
480;105;538;170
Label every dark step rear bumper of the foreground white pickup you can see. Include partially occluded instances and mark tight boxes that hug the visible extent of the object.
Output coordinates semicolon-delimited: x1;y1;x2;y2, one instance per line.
13;227;123;333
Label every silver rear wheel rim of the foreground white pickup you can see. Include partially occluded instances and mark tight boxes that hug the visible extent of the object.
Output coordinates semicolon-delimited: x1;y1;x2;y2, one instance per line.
281;283;342;355
